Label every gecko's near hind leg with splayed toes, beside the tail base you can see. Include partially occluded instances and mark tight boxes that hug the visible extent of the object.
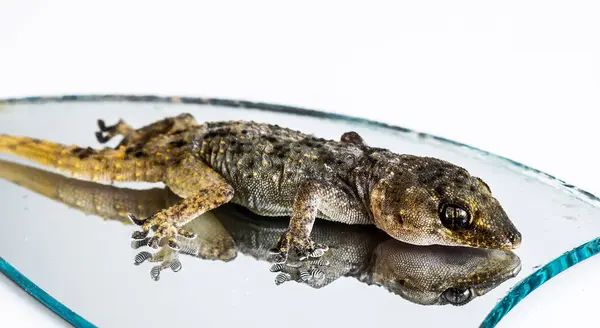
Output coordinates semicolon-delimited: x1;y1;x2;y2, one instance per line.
129;156;233;280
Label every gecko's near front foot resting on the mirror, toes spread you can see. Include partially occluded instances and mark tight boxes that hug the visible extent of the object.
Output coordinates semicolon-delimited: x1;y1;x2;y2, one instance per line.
269;231;329;263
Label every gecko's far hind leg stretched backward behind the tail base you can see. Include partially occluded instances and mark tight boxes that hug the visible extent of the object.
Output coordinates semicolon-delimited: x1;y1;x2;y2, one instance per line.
96;113;198;146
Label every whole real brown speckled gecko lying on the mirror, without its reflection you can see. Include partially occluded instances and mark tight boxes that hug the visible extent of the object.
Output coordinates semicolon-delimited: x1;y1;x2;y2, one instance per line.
0;113;521;272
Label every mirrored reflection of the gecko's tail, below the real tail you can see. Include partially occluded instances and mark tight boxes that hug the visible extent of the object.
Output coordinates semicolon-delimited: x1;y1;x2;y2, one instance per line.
0;158;174;224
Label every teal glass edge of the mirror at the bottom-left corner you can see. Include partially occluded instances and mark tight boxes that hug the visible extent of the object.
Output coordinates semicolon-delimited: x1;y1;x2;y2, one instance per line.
0;257;96;327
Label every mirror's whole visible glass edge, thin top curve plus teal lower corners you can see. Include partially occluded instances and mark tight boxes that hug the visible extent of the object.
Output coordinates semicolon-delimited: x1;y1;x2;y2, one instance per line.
0;94;600;328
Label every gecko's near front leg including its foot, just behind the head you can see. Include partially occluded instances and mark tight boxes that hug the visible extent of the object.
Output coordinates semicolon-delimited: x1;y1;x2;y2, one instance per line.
271;180;347;263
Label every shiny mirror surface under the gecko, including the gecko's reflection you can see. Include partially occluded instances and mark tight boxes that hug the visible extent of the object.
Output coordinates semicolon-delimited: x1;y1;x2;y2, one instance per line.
0;101;600;327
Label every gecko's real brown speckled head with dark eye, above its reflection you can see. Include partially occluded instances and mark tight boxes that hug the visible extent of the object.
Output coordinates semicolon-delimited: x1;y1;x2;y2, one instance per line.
371;155;521;249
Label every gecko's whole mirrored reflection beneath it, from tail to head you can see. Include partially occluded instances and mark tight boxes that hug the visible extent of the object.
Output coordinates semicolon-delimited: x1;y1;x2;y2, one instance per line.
0;160;521;305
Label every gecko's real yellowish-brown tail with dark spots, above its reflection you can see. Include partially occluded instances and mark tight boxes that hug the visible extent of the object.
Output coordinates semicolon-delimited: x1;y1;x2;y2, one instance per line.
0;134;166;182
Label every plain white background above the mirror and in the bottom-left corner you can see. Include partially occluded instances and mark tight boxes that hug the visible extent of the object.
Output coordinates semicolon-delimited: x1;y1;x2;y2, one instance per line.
0;0;600;326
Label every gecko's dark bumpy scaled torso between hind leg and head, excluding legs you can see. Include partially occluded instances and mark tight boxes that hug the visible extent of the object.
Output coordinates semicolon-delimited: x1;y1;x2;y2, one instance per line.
192;121;370;223
